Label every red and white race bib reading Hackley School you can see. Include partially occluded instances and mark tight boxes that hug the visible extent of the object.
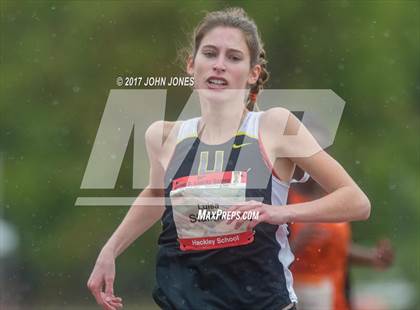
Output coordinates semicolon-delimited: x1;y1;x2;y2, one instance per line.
170;171;254;251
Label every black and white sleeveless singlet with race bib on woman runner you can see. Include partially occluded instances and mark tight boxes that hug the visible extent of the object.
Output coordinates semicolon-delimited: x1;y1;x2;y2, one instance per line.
153;112;296;310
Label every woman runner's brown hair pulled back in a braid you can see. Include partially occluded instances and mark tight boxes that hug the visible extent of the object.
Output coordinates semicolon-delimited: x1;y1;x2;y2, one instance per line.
189;8;269;111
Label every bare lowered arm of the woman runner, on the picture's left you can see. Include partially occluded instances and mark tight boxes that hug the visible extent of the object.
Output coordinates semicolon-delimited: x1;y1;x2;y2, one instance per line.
87;122;169;310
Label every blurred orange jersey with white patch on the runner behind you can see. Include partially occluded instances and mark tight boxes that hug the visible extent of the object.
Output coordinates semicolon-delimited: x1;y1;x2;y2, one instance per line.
289;191;351;310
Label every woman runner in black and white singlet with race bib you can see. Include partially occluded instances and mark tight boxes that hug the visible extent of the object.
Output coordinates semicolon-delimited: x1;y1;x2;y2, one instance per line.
88;8;370;310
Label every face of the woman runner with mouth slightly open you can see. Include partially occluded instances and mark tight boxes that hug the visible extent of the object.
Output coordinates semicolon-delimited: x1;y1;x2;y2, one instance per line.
187;27;261;94
